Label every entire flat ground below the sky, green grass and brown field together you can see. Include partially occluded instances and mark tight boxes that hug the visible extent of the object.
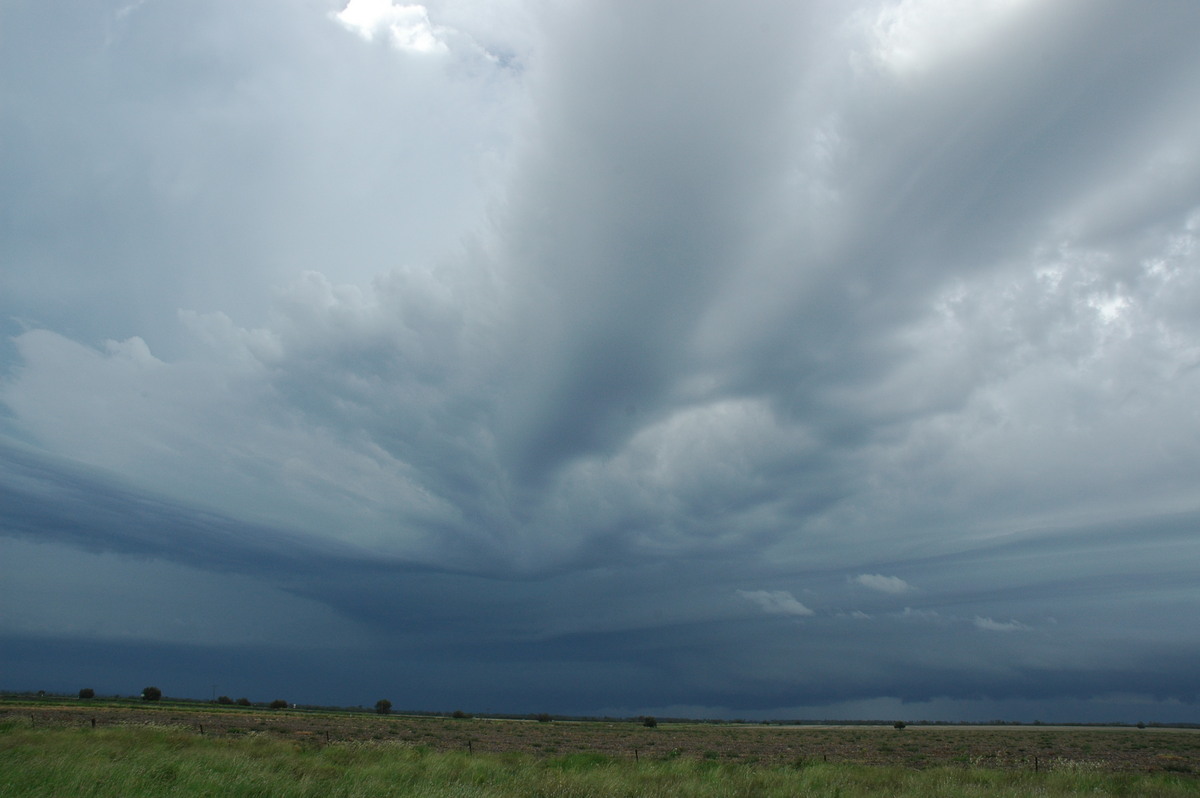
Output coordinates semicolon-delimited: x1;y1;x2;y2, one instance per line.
0;704;1200;798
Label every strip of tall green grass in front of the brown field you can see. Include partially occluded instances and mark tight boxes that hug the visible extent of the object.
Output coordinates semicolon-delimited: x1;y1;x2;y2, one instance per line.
7;722;1200;798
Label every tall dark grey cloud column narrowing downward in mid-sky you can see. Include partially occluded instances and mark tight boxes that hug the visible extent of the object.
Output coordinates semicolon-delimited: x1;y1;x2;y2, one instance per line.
489;6;825;478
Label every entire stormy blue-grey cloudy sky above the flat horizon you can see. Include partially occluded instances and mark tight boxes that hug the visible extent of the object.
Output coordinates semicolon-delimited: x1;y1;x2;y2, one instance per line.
0;0;1200;722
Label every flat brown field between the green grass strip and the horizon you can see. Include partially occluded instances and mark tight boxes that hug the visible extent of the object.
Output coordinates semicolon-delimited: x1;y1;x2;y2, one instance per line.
0;702;1200;775
